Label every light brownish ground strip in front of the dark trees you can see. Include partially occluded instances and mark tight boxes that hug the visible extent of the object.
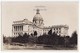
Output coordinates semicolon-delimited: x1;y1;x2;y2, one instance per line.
3;44;77;50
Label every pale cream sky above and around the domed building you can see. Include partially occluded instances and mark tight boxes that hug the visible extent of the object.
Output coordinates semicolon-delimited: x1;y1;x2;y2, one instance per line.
2;2;78;36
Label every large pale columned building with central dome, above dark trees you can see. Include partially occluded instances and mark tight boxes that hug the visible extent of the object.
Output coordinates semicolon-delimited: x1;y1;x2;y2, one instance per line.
12;9;69;37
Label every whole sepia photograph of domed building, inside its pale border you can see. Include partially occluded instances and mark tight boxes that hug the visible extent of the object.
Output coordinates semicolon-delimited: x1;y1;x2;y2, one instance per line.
1;1;78;50
